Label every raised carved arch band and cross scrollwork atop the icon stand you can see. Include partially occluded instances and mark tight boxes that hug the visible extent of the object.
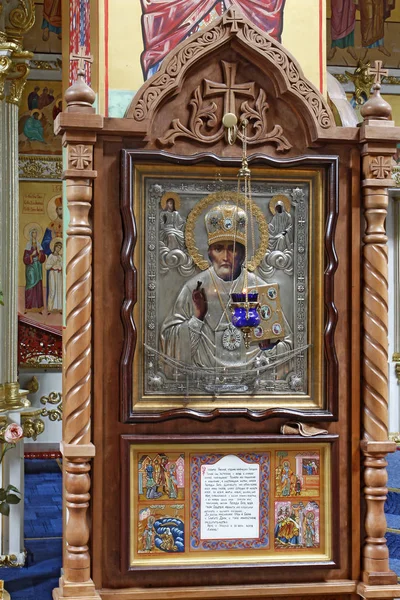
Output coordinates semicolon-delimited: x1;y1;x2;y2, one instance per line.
126;6;335;144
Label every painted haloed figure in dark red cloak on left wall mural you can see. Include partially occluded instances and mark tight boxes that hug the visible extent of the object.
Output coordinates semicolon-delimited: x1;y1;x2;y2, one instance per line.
23;228;46;313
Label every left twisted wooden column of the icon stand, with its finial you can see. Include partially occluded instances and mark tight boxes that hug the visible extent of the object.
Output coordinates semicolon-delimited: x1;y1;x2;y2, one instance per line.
53;68;102;600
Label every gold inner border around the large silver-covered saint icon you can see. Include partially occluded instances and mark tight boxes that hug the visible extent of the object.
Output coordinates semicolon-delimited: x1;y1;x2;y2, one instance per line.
130;162;327;414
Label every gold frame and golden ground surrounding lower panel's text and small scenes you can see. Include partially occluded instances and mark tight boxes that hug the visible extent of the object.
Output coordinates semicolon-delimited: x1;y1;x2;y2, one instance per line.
121;436;338;570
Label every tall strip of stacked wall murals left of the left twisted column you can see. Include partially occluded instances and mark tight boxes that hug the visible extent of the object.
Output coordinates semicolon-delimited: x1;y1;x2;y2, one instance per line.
18;0;64;360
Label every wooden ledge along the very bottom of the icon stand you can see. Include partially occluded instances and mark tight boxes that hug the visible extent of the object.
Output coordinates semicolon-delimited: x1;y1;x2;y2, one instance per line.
98;580;357;600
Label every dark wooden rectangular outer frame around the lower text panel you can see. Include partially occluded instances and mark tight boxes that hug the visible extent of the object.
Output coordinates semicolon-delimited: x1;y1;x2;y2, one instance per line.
120;434;340;574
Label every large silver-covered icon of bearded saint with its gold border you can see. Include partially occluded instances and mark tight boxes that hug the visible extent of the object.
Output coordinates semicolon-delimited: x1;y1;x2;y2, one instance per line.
123;165;336;419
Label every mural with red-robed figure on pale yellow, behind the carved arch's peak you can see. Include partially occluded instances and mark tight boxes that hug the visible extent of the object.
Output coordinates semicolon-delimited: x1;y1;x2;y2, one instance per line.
104;0;325;117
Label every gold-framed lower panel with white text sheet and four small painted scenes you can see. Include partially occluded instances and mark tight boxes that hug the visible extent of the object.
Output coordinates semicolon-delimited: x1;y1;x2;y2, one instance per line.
124;440;333;568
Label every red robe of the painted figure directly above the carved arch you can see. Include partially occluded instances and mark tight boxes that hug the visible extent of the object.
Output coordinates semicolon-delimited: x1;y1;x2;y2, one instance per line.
141;0;286;79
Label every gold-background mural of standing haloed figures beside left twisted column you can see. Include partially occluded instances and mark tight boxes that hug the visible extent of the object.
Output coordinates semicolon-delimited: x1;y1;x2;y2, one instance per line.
18;181;63;331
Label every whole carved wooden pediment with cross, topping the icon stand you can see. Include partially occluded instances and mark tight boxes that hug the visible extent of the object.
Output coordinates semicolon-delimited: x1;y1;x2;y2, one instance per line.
126;6;335;156
